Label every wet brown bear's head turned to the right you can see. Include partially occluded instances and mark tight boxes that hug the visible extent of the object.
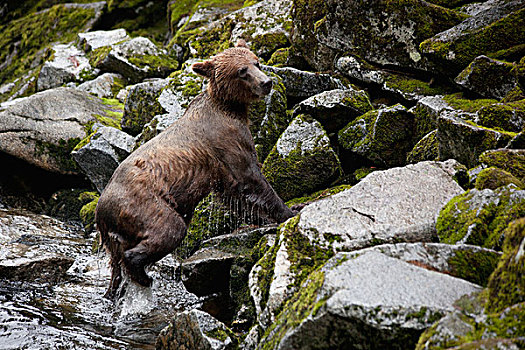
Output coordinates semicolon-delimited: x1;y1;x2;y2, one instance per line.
191;40;272;103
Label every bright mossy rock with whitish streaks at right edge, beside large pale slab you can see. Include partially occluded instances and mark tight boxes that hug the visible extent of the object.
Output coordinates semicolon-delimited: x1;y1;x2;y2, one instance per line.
436;185;525;249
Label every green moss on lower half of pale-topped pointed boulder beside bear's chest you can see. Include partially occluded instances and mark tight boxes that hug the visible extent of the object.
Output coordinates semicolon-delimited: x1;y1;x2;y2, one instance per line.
262;115;342;201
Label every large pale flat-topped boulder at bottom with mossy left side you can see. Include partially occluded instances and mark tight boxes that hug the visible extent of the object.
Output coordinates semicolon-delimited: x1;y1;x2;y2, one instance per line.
261;252;480;349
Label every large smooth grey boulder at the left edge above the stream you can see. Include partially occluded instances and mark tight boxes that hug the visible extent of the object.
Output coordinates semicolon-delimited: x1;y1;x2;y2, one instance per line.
0;88;116;174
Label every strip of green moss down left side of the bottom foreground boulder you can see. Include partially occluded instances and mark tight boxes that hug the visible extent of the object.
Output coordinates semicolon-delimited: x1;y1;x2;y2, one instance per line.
260;270;325;350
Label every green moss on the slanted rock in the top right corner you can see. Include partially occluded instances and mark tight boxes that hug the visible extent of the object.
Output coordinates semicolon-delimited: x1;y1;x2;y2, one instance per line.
420;9;525;75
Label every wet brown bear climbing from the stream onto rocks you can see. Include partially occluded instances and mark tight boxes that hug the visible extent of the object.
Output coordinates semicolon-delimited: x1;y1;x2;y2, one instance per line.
96;41;293;298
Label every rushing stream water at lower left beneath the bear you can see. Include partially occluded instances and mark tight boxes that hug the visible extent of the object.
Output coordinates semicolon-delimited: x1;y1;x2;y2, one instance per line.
0;209;203;350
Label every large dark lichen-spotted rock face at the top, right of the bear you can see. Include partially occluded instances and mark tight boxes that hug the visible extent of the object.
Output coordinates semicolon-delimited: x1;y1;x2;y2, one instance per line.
292;0;465;70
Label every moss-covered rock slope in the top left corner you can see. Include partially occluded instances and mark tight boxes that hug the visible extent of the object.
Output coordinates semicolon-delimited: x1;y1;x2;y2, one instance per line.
0;4;101;102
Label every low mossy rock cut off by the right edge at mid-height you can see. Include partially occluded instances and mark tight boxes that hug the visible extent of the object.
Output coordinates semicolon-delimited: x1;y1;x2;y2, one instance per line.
479;149;525;182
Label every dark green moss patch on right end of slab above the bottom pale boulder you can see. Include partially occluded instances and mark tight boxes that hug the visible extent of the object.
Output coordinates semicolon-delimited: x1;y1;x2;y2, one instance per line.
447;250;500;286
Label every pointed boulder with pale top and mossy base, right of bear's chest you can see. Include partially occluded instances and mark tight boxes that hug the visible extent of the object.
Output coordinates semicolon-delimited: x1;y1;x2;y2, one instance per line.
262;115;342;201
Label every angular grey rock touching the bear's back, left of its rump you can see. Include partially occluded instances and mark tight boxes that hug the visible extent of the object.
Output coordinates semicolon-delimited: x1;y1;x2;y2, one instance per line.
72;126;135;193
